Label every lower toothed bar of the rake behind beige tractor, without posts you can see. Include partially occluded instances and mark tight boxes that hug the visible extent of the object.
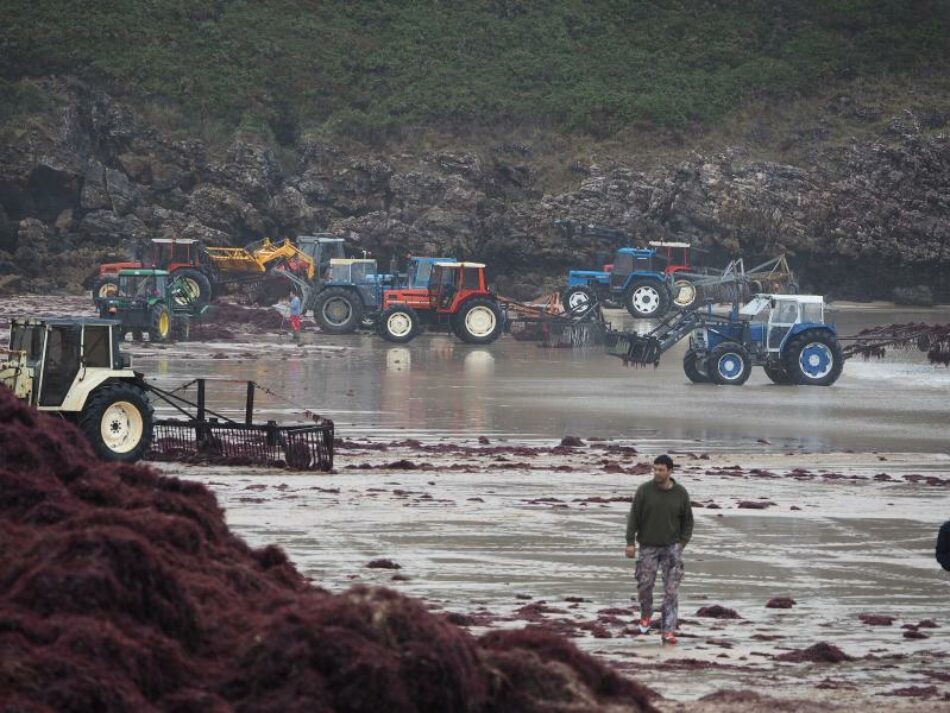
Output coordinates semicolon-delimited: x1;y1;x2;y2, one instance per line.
145;419;333;471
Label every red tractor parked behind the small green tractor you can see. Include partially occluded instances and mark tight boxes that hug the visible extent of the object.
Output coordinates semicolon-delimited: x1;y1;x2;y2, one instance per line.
85;238;211;305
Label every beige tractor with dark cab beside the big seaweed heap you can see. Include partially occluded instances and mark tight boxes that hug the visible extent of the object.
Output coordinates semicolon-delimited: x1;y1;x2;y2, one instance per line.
0;317;153;462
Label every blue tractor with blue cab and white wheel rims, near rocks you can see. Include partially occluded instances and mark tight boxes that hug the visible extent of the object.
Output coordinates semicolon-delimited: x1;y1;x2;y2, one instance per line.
561;248;673;319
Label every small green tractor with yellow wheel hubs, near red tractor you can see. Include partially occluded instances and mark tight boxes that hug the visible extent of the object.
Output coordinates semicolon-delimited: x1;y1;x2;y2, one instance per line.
96;269;200;342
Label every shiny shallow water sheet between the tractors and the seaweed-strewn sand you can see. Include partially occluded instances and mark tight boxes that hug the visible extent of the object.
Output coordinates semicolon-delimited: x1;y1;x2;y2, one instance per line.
126;308;950;451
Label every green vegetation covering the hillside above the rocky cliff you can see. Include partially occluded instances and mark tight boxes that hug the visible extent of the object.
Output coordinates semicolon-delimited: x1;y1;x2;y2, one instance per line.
0;0;950;143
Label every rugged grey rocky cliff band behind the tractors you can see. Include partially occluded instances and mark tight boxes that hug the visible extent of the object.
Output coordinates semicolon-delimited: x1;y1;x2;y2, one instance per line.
0;78;950;299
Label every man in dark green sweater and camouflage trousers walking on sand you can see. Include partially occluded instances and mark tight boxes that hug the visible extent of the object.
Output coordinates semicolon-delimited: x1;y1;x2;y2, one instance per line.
625;455;693;644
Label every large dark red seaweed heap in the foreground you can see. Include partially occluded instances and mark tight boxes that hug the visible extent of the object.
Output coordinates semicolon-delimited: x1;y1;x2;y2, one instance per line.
0;391;653;712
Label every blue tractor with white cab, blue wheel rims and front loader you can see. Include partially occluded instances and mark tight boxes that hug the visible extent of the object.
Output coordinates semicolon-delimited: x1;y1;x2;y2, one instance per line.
606;294;845;386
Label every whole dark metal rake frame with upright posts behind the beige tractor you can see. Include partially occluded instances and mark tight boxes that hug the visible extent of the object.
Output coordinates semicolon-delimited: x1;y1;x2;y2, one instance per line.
146;379;334;471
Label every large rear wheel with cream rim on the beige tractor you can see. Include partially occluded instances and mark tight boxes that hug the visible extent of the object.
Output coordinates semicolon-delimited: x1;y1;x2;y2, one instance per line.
79;382;154;463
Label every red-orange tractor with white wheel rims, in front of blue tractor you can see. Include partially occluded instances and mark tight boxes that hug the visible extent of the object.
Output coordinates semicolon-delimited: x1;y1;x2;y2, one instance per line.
376;262;505;344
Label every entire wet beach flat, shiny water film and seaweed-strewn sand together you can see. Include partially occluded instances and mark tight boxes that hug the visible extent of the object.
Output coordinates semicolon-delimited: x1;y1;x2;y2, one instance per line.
0;302;950;710
